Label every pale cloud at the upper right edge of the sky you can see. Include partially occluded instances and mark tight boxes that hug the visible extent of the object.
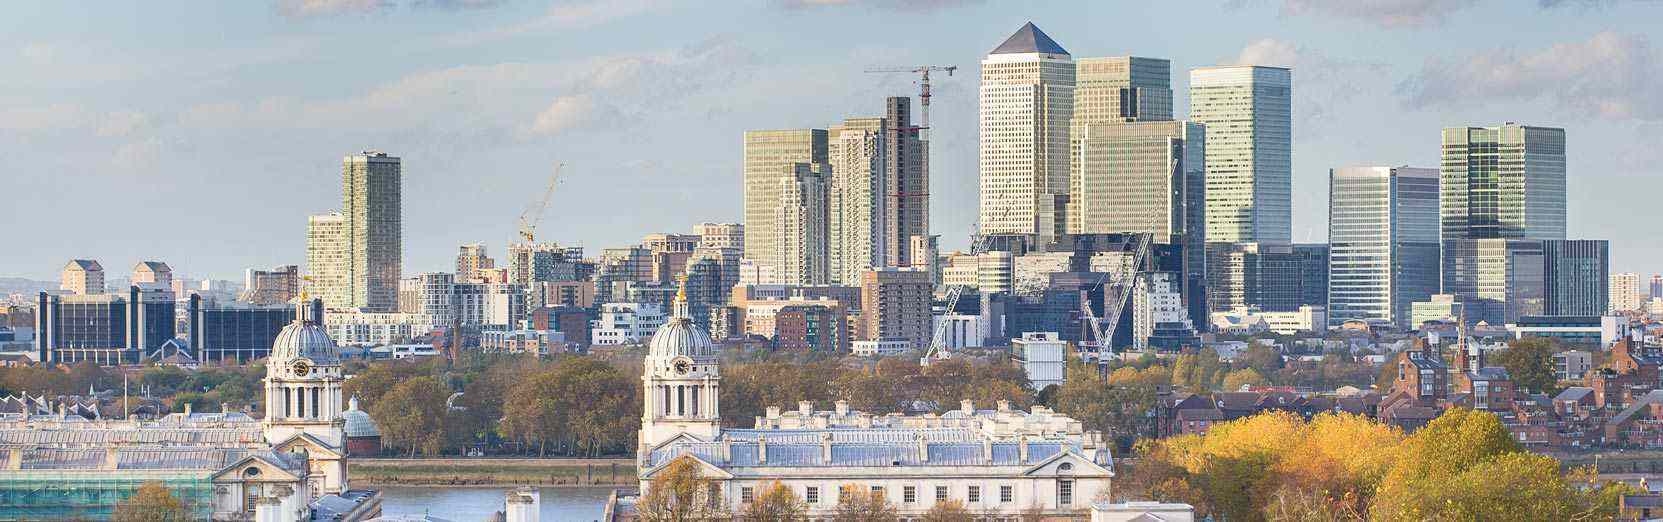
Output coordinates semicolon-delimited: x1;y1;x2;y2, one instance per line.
1399;32;1663;120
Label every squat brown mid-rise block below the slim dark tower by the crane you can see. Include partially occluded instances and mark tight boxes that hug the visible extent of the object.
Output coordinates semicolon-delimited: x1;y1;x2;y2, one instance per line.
860;268;933;347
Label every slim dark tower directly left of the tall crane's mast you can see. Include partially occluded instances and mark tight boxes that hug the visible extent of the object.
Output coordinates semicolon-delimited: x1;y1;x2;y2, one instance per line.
884;96;933;266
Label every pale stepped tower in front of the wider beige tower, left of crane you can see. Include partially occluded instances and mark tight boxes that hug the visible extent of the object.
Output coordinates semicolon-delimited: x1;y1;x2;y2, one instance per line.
778;163;830;284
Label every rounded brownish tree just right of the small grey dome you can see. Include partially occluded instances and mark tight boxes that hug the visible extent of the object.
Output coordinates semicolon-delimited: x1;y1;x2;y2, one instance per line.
369;377;451;456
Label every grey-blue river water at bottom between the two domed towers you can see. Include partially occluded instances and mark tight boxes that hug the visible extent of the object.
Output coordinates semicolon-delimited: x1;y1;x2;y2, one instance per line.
376;485;614;522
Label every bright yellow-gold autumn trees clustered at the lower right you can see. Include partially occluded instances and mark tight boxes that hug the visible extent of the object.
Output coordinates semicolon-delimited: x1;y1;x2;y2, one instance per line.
1116;409;1635;520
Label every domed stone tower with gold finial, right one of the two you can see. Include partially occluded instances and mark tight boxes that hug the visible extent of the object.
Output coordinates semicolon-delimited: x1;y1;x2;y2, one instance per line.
640;281;722;447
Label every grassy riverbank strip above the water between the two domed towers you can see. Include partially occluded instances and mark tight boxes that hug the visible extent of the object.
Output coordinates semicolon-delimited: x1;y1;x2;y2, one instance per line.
346;459;640;487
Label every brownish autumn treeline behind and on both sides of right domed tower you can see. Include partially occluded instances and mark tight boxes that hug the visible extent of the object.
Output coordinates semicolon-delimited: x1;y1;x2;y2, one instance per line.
344;352;1034;457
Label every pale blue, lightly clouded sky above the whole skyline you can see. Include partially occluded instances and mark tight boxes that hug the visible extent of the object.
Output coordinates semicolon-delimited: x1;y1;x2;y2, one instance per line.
0;0;1663;279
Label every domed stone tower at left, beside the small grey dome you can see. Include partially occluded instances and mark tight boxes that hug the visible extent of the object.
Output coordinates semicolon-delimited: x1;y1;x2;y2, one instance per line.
263;299;346;497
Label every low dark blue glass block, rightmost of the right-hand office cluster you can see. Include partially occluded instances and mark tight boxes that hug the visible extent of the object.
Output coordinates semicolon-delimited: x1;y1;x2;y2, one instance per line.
1542;239;1611;316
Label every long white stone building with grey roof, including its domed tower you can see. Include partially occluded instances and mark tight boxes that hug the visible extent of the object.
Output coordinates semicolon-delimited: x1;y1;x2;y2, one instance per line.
637;295;1114;519
